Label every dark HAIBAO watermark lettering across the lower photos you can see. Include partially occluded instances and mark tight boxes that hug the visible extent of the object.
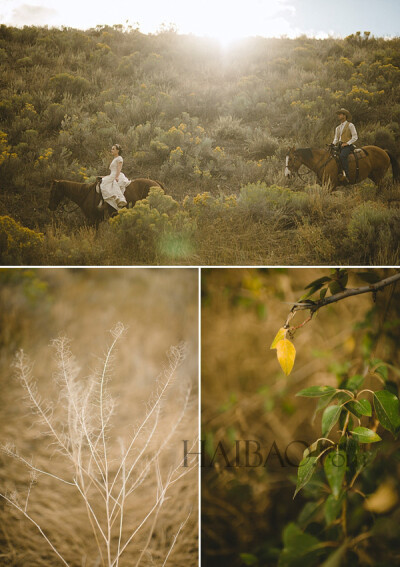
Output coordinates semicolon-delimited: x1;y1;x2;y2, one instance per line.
183;439;309;468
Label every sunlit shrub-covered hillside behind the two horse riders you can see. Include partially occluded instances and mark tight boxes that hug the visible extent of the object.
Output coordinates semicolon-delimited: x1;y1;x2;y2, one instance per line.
0;26;400;264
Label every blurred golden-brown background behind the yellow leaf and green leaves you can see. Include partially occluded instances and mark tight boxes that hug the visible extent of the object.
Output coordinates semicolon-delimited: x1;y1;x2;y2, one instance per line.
202;268;400;567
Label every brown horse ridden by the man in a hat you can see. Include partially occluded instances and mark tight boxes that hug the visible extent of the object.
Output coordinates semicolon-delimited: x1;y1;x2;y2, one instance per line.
285;146;400;189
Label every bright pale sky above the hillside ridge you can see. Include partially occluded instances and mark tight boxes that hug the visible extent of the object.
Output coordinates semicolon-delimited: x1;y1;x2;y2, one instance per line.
0;0;400;43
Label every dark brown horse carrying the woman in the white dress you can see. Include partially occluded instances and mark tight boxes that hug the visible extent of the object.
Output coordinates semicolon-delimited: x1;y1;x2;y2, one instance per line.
49;178;165;226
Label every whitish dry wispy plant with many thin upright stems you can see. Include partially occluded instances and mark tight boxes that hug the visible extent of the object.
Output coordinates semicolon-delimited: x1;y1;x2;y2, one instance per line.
0;323;194;567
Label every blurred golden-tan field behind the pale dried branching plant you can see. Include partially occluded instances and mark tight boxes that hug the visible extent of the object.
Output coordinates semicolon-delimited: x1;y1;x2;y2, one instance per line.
0;268;198;567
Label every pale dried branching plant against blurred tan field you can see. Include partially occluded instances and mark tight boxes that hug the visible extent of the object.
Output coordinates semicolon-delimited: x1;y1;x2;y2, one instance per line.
0;323;197;567
